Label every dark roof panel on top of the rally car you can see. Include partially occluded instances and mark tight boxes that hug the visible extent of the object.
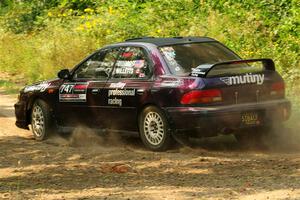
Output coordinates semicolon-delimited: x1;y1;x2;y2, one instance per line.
124;37;216;46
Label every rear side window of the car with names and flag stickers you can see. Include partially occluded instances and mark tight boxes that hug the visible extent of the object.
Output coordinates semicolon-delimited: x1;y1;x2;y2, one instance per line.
113;47;150;79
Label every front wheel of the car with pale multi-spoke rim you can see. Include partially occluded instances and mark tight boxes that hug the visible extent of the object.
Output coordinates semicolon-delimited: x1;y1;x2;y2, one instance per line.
31;99;55;141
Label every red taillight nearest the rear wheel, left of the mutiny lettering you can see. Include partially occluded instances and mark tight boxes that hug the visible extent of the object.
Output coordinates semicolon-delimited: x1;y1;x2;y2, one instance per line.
180;89;222;104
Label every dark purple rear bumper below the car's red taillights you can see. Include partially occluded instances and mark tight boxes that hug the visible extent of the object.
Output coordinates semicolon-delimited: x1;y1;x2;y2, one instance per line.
165;99;291;135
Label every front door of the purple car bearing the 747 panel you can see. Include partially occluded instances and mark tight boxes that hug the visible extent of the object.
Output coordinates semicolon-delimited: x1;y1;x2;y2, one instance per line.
58;49;116;127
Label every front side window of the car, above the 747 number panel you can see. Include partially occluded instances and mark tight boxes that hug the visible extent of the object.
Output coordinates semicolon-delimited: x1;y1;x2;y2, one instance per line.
74;49;119;79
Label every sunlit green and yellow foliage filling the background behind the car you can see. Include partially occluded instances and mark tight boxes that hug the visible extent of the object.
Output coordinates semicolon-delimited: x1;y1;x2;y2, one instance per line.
0;0;300;97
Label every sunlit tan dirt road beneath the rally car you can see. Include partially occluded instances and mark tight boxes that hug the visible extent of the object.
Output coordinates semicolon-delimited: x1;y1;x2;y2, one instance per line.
0;91;300;199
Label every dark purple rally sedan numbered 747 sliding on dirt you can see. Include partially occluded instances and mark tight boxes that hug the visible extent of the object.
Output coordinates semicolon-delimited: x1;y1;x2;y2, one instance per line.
15;37;291;151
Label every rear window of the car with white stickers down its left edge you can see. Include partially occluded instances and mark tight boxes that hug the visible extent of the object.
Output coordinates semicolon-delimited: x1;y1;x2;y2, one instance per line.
159;42;240;76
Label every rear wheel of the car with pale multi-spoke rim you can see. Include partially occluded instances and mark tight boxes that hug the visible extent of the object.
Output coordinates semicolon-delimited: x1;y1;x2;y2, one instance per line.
139;106;174;151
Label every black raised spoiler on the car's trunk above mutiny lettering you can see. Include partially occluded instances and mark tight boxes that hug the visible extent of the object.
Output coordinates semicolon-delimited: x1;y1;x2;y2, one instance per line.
203;58;275;77
